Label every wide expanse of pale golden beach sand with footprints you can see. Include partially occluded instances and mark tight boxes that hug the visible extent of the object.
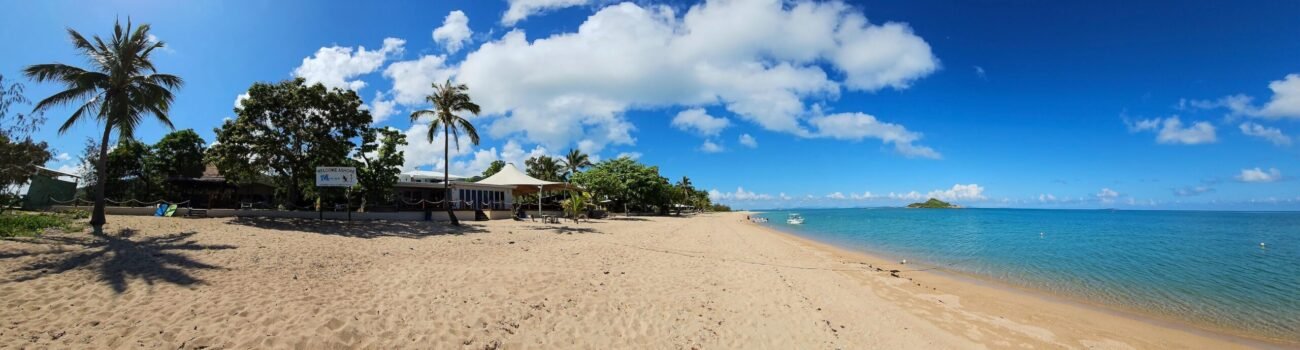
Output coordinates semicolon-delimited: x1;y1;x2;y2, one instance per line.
0;213;1268;349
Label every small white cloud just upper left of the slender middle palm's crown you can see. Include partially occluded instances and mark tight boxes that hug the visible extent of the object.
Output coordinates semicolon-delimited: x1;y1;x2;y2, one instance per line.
384;56;455;105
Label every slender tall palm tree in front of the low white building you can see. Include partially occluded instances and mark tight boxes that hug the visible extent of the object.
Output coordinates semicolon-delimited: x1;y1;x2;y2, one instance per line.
411;79;480;226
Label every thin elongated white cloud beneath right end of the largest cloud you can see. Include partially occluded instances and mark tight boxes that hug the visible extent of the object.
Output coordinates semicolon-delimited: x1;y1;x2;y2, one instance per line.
809;113;943;159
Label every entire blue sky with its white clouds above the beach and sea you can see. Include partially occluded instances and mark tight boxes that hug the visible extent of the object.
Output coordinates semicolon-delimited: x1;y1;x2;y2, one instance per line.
0;0;1300;209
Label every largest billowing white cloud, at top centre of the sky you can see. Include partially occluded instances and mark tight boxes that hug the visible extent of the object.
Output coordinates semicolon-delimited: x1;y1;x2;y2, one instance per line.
457;0;937;155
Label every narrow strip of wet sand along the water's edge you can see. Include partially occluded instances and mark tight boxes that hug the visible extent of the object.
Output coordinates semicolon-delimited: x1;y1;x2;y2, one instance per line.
741;211;1300;349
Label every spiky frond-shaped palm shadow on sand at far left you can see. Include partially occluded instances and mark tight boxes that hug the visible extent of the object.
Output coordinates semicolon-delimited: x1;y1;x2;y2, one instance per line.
0;229;235;294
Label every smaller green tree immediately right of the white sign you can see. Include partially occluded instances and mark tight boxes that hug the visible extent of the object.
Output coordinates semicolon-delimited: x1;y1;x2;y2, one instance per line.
356;128;407;212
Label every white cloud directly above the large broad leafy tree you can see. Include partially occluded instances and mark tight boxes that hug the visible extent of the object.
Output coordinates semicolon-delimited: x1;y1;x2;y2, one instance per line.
294;38;406;91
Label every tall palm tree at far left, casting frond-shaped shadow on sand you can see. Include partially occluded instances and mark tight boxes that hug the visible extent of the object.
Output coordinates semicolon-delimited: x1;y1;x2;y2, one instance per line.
23;18;183;234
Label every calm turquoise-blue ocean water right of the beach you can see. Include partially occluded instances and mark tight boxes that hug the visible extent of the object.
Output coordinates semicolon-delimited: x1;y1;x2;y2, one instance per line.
759;208;1300;342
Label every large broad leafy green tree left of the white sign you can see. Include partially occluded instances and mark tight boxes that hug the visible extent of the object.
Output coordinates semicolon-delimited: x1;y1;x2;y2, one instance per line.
208;78;371;208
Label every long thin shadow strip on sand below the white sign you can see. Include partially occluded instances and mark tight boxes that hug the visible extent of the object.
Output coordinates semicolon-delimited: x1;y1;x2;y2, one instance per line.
230;216;488;238
